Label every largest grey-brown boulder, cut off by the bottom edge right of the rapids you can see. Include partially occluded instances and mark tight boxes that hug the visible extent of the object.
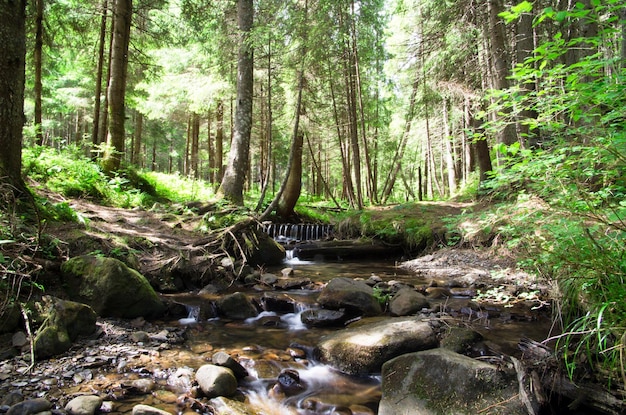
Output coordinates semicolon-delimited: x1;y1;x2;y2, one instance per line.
378;349;527;415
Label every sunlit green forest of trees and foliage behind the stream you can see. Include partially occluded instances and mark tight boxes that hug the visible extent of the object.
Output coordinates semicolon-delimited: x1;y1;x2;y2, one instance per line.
0;0;626;394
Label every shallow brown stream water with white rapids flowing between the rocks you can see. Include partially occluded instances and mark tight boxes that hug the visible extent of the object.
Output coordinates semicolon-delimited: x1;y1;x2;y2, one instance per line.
149;252;549;414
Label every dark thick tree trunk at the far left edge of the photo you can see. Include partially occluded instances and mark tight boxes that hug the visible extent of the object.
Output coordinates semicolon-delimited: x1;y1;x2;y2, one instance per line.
0;0;26;196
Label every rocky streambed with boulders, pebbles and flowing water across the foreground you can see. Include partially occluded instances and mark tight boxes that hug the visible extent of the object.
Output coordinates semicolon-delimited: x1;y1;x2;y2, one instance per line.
0;250;572;415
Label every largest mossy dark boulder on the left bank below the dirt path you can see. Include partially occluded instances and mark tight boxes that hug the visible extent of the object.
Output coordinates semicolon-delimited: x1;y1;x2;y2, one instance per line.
61;255;165;318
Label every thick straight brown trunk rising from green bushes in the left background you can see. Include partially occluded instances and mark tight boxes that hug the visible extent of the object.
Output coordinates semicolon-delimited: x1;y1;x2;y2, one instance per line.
102;0;133;173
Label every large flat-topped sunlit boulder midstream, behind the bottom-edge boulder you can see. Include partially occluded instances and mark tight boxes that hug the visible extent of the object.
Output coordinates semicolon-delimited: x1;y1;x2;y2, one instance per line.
317;317;438;375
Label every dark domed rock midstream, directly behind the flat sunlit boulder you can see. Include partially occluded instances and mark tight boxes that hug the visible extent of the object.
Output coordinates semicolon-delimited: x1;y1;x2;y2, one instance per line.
317;278;382;316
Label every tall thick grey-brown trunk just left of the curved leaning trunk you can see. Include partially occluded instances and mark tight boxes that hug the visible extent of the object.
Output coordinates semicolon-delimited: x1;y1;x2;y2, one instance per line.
217;0;254;205
